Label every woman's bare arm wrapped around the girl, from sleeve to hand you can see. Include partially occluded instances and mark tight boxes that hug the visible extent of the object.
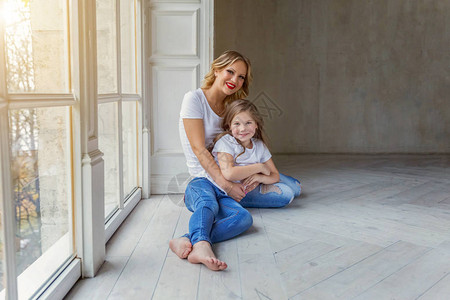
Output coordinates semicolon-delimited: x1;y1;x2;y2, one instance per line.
183;119;245;201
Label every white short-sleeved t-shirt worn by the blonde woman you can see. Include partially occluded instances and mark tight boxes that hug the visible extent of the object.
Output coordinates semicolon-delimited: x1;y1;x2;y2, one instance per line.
178;89;222;177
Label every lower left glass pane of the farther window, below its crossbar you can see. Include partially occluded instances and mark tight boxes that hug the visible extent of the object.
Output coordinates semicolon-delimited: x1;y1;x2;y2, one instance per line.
98;102;120;218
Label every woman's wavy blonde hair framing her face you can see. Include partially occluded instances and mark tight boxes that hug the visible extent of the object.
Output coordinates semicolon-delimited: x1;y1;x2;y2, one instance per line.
202;50;253;106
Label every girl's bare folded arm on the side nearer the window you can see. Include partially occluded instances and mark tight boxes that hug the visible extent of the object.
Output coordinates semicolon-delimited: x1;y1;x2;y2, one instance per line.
217;152;270;181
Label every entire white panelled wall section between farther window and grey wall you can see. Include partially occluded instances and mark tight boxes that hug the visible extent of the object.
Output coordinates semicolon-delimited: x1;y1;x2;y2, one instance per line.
145;0;214;194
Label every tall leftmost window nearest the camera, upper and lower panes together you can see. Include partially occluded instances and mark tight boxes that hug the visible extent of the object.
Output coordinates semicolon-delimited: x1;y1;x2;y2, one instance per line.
0;0;75;299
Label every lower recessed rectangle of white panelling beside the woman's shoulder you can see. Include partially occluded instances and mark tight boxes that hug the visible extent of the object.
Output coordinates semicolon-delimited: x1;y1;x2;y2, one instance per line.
152;65;199;155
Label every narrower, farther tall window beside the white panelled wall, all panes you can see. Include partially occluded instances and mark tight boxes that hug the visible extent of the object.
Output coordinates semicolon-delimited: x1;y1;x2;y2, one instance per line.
96;0;140;219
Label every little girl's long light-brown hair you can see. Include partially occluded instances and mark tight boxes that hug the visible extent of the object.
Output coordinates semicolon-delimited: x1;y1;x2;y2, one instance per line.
213;100;268;162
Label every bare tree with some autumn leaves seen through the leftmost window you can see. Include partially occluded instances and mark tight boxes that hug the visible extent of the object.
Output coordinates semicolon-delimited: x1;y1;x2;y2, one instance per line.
0;1;42;289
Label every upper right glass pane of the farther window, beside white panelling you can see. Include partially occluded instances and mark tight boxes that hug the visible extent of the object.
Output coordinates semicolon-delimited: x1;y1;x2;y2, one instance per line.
120;0;137;94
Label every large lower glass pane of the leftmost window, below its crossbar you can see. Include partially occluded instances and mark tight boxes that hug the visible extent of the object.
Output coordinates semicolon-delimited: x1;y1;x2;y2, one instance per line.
9;107;73;299
